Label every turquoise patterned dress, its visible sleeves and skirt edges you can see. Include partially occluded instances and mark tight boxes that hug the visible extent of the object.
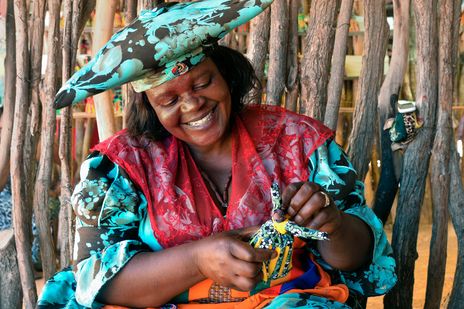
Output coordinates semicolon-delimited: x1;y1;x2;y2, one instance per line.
38;140;397;308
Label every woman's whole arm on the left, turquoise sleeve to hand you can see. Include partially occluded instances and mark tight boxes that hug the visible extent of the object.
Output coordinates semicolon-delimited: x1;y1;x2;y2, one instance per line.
72;154;272;307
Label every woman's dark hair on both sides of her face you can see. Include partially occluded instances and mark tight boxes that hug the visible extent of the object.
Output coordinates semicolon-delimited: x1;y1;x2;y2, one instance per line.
126;46;261;140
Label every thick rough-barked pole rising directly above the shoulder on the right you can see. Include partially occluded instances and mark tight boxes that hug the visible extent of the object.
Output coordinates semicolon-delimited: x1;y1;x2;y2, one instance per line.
300;0;340;121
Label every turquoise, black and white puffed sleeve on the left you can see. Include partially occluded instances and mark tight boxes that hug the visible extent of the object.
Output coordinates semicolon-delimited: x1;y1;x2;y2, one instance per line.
72;153;149;308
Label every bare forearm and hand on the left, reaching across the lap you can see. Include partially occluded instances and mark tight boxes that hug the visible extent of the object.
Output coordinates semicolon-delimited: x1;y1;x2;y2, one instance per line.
97;228;272;307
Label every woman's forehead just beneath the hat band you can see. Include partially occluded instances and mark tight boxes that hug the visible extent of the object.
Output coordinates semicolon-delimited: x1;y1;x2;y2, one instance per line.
147;58;218;95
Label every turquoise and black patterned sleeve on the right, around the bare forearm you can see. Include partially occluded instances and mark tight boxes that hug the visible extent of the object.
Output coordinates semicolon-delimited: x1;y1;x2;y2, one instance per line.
309;140;397;296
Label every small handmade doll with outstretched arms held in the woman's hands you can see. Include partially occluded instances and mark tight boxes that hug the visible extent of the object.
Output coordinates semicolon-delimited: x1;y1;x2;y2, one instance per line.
250;182;329;282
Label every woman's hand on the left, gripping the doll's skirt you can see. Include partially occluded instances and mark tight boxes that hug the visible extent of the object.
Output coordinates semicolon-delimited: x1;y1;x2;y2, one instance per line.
195;227;274;291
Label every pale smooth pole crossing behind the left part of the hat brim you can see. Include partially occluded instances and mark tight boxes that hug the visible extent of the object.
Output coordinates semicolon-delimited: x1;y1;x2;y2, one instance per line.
93;0;117;141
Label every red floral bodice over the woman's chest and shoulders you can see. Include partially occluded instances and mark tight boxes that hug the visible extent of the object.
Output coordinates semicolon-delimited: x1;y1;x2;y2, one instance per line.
95;105;333;248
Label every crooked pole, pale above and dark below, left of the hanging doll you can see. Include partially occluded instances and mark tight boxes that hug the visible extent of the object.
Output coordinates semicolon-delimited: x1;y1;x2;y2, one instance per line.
373;0;411;224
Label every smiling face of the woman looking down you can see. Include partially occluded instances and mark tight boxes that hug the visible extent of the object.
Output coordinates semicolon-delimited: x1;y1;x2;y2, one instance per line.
146;59;231;150
